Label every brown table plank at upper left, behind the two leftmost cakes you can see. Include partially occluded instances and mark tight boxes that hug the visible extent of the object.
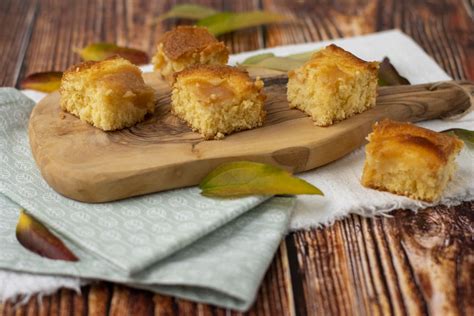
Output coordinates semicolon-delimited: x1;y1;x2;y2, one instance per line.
16;0;262;82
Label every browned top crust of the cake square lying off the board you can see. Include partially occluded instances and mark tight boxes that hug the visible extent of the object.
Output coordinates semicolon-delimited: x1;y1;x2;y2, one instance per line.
371;119;464;164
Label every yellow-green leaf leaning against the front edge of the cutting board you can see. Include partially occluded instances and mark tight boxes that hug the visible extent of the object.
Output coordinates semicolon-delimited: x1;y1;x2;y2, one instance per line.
199;161;323;197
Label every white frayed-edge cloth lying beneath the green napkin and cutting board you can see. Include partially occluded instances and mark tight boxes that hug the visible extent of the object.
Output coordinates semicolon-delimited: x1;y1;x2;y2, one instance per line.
9;30;474;301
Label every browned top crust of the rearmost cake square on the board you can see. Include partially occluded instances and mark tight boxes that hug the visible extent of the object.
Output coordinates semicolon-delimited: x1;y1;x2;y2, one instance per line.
159;26;225;60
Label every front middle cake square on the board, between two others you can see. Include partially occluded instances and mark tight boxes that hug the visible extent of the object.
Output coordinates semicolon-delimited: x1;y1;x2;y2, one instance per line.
171;65;266;139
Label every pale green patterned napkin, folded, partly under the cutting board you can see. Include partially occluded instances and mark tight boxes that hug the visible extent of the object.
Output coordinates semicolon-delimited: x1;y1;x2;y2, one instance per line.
0;88;294;310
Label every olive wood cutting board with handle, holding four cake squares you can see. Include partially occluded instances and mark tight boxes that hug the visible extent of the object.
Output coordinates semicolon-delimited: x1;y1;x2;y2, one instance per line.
29;69;474;202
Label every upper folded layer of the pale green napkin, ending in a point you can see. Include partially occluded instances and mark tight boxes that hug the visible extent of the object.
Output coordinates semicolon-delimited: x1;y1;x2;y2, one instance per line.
0;88;267;274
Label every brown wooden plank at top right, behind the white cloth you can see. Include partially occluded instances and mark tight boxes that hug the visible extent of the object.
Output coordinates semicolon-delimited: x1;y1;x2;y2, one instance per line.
263;0;474;79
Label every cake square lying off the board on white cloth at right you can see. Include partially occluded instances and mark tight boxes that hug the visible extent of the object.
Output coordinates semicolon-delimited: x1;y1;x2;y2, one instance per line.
361;120;464;202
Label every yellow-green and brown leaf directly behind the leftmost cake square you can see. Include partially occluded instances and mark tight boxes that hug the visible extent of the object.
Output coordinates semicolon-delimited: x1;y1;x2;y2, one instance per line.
76;43;150;65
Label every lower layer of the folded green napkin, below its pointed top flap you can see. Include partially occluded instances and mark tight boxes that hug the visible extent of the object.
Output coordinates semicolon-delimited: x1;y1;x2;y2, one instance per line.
0;195;294;310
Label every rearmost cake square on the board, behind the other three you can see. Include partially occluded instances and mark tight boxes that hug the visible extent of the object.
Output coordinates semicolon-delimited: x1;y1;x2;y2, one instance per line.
152;26;229;84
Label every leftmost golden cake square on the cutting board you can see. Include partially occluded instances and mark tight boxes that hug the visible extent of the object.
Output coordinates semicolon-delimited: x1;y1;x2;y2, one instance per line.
60;57;156;131
